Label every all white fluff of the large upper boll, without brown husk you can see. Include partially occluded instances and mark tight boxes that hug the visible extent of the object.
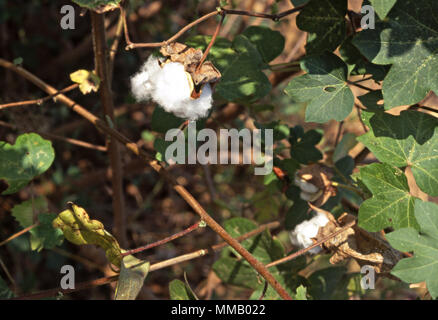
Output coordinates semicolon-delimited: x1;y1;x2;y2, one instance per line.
131;56;213;120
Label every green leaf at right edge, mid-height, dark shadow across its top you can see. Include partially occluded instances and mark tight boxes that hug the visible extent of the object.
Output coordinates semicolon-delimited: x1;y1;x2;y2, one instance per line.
358;110;438;196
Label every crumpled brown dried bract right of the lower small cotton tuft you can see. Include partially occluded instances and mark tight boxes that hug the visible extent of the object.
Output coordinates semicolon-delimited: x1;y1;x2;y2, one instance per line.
316;212;403;274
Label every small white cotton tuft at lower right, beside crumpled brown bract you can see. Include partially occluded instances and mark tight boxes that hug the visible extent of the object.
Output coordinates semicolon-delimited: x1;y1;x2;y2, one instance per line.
289;212;329;254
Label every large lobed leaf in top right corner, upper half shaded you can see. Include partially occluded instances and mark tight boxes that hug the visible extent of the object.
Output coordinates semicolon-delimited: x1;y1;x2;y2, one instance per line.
353;0;438;109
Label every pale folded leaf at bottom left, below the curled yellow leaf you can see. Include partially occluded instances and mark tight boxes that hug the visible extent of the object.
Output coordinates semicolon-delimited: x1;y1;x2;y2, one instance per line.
114;255;149;300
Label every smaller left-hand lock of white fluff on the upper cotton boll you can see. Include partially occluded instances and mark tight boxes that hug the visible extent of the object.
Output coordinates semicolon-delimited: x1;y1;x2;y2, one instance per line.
131;55;161;101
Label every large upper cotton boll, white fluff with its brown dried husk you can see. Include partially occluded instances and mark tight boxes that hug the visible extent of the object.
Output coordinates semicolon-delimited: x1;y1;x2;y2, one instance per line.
131;43;220;121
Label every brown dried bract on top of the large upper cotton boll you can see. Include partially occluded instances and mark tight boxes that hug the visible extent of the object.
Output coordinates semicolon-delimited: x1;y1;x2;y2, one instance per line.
160;42;221;89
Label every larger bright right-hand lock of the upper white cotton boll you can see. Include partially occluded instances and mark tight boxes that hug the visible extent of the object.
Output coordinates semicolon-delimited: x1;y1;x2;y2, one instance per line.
152;62;212;120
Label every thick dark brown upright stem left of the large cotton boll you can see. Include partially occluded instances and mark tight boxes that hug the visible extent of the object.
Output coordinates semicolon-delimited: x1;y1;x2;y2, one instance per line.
90;12;127;247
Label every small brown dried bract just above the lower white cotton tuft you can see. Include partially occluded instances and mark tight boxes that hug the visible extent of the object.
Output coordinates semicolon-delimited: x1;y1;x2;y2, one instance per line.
297;164;336;207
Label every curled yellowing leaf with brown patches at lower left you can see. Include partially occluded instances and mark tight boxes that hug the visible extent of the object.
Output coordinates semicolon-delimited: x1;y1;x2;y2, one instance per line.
53;203;122;268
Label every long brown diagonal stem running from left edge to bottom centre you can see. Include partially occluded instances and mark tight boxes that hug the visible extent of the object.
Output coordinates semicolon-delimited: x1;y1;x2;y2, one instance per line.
0;58;292;300
